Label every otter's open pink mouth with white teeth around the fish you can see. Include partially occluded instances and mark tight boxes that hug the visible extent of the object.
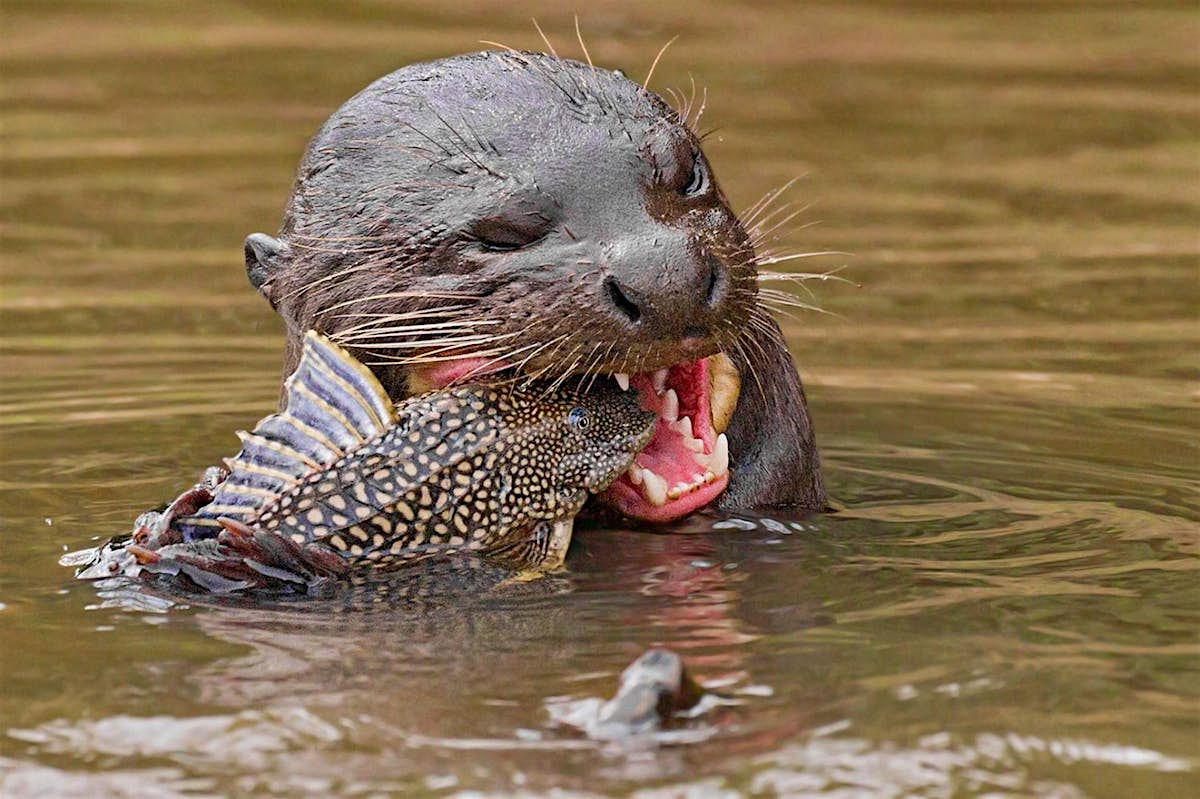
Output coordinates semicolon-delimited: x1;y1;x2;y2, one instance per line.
419;353;740;523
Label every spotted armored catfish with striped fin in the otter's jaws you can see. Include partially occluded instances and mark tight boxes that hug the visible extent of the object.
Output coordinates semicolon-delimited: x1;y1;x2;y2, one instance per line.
78;331;656;593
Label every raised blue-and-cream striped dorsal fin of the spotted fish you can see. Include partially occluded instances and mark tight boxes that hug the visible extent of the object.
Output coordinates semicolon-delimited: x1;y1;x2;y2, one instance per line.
176;330;396;537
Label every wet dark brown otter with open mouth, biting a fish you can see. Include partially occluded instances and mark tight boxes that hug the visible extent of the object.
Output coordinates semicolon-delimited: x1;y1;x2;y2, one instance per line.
246;50;827;522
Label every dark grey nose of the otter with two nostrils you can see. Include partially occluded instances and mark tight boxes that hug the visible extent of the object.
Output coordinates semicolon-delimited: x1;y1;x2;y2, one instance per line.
604;245;728;338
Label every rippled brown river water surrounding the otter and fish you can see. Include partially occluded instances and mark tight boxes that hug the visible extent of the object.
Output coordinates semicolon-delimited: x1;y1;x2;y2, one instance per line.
0;0;1200;798
